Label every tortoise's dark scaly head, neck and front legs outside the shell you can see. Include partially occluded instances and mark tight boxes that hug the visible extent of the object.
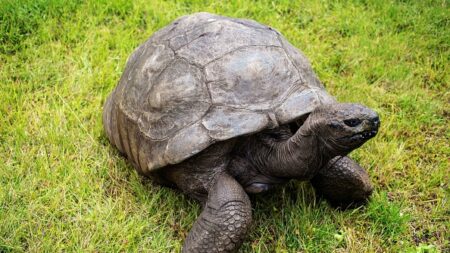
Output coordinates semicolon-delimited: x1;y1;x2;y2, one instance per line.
154;104;380;252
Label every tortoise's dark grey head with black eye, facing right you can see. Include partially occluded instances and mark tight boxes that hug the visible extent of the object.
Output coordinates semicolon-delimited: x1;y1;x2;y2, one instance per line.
308;103;380;155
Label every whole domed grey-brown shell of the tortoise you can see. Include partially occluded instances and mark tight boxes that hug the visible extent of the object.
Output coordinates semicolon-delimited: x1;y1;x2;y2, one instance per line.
103;13;334;174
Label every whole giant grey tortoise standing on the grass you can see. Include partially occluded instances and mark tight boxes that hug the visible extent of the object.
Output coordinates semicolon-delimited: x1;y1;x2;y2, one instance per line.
103;13;380;253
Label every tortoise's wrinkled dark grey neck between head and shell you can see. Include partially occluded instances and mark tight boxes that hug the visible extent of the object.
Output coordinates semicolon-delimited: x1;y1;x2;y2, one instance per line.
253;116;348;180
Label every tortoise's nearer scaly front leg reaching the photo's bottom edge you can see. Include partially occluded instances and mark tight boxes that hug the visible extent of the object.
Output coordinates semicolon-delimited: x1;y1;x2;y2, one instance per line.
182;173;251;253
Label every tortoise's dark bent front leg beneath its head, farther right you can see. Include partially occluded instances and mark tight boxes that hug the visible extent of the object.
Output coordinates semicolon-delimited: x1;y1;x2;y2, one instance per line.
311;156;373;208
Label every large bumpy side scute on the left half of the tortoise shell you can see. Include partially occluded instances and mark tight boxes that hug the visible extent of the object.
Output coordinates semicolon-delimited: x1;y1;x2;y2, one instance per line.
138;60;210;140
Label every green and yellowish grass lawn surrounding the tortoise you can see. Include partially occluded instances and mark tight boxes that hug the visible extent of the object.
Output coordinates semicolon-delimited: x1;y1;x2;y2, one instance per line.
0;0;450;252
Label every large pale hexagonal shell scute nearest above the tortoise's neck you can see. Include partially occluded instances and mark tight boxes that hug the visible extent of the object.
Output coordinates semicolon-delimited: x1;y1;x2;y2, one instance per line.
205;46;300;110
